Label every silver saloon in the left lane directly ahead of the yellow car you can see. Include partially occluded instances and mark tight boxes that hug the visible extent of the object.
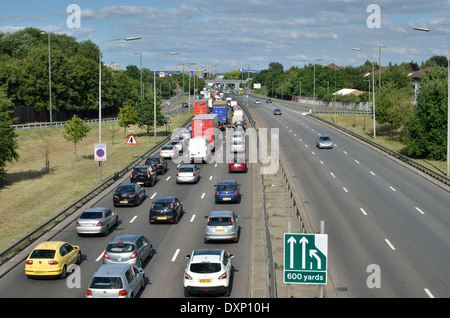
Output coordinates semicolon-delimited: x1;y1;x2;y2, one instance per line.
76;208;119;236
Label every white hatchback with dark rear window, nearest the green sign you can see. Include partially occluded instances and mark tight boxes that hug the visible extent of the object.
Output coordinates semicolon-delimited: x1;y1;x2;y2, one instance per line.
183;249;234;297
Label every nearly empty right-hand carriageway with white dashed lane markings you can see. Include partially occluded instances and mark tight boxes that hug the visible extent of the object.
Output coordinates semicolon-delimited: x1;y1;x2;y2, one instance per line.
248;97;450;298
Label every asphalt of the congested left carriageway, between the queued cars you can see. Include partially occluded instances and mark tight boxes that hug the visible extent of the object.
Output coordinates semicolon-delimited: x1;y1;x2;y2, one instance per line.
0;103;252;298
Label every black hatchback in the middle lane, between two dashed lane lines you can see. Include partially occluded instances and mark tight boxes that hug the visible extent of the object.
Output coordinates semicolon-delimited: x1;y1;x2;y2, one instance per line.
149;197;183;223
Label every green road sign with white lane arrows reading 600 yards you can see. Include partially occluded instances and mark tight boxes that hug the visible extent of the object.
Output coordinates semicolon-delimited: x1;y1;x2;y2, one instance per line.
283;233;328;285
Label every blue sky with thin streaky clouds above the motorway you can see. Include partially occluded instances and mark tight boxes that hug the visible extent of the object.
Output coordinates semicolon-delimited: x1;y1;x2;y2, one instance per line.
0;0;450;72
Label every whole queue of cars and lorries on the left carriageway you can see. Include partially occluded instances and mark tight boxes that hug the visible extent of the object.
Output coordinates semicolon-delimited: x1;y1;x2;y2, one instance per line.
25;87;248;298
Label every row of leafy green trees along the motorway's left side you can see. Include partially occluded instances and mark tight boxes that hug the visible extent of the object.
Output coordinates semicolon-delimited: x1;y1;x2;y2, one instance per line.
0;27;205;182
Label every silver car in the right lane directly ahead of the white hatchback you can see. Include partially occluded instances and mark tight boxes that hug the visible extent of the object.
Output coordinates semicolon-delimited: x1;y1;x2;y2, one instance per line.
203;211;240;243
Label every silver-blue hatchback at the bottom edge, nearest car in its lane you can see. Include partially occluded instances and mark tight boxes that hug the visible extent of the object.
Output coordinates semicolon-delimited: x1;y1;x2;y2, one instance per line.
86;264;145;298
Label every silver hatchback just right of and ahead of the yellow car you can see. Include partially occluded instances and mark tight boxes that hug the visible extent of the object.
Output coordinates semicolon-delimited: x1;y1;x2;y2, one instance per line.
103;234;153;267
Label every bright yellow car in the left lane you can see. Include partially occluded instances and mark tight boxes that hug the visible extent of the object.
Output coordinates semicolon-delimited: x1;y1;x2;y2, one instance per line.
25;241;81;278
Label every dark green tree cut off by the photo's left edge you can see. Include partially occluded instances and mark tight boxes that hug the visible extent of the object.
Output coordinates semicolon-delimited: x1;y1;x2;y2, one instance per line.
0;87;19;183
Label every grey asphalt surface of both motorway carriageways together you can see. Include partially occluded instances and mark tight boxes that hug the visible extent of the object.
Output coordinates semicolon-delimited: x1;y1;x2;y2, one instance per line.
0;94;450;298
